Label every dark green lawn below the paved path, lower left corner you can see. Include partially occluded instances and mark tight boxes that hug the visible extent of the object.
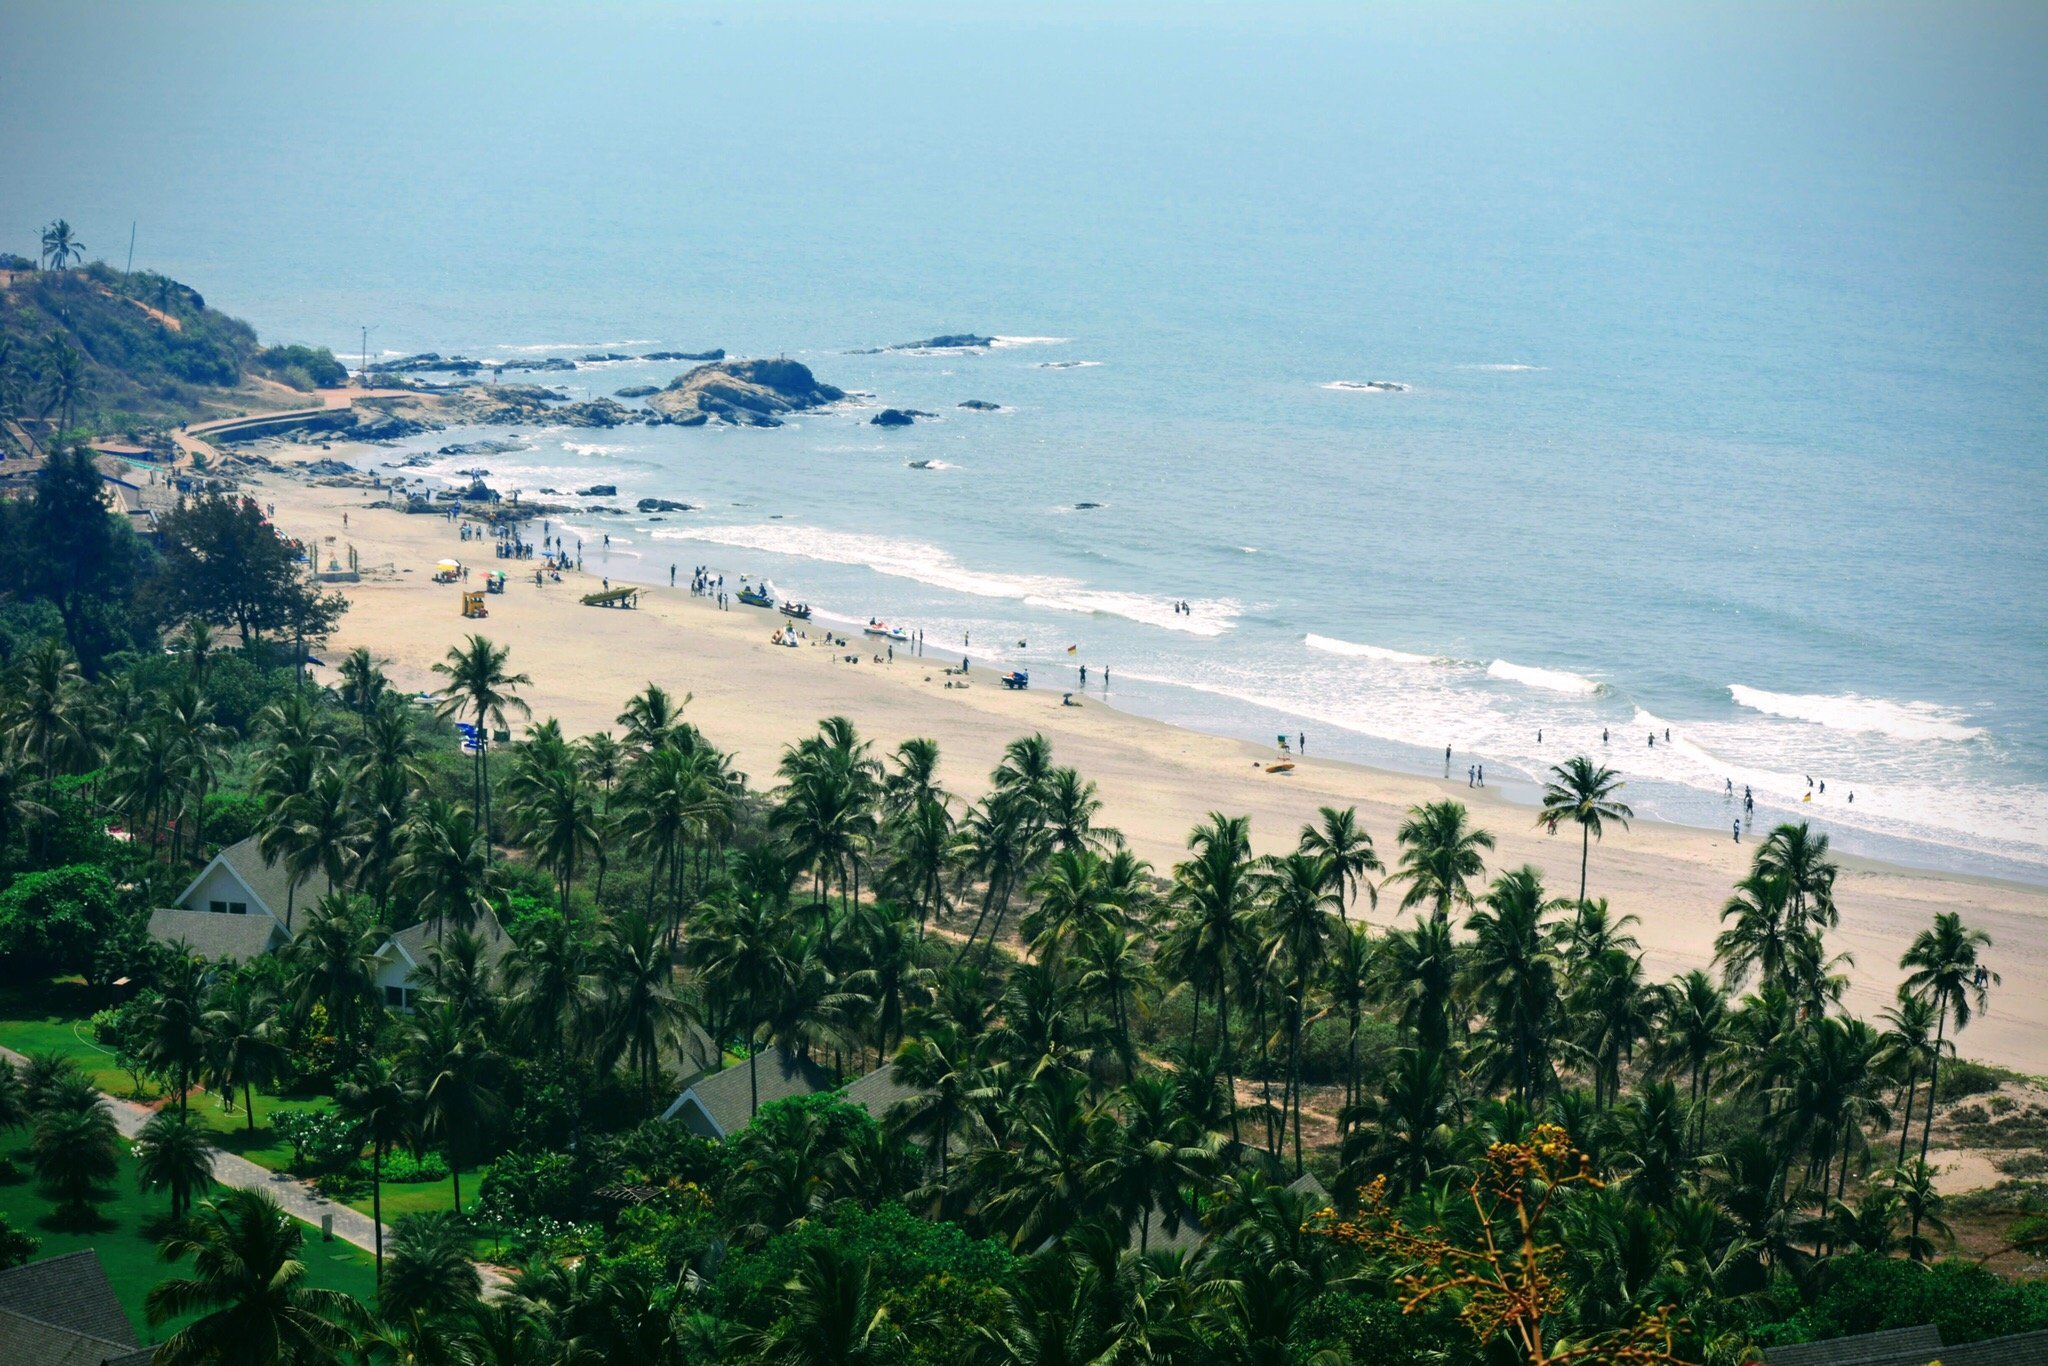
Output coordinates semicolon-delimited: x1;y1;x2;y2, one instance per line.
0;1130;377;1341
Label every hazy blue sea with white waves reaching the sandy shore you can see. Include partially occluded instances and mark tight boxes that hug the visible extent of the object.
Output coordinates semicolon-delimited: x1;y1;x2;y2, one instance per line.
0;4;2048;881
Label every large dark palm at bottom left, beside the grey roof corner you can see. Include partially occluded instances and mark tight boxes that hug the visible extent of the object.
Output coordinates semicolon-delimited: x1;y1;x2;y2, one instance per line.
143;1190;369;1366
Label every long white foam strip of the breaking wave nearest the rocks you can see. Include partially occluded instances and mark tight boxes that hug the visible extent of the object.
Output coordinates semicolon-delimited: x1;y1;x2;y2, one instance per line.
653;524;1241;637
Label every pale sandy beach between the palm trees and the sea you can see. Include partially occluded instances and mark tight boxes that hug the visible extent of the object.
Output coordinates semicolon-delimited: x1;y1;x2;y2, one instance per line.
258;444;2048;1073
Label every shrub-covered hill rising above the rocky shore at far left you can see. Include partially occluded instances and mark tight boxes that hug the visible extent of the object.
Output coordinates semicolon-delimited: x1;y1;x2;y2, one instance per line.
0;221;348;432
